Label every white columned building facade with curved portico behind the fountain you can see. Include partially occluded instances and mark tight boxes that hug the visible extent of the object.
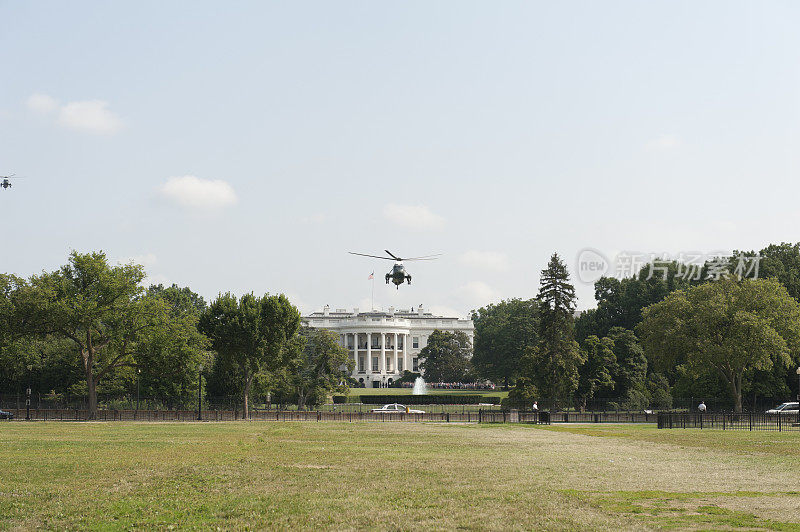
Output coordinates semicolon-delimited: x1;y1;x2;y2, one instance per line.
303;305;475;388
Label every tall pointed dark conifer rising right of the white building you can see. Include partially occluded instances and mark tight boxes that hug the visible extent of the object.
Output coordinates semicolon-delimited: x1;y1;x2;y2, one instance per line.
524;253;584;408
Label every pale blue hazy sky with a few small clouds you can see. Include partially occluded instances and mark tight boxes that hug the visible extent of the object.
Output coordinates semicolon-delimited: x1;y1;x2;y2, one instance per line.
0;0;800;316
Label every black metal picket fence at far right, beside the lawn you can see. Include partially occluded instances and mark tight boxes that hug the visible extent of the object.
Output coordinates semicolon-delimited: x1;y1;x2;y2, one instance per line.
657;412;800;432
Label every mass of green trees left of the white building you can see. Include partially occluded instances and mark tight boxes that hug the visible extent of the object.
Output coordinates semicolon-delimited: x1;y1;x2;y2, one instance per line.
0;251;353;418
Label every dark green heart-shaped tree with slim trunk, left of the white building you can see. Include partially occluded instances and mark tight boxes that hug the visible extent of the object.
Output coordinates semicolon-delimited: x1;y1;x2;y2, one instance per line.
199;293;300;419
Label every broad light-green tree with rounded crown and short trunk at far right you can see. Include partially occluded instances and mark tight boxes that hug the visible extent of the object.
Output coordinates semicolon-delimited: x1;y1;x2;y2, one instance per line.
637;279;800;412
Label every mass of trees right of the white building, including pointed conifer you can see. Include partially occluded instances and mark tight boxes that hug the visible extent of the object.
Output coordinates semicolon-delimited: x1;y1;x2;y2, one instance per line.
472;243;800;411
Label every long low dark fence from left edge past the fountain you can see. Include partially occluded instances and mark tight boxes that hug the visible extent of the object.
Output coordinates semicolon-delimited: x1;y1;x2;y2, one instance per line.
0;408;550;425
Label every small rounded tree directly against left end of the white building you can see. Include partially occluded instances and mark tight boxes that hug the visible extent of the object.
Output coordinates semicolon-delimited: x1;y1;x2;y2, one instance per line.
287;329;355;410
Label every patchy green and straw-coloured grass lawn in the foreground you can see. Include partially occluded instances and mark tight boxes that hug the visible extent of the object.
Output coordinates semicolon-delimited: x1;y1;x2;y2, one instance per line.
0;422;800;530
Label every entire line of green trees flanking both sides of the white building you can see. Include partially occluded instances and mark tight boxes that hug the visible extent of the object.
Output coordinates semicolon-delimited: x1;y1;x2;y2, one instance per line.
0;244;800;415
